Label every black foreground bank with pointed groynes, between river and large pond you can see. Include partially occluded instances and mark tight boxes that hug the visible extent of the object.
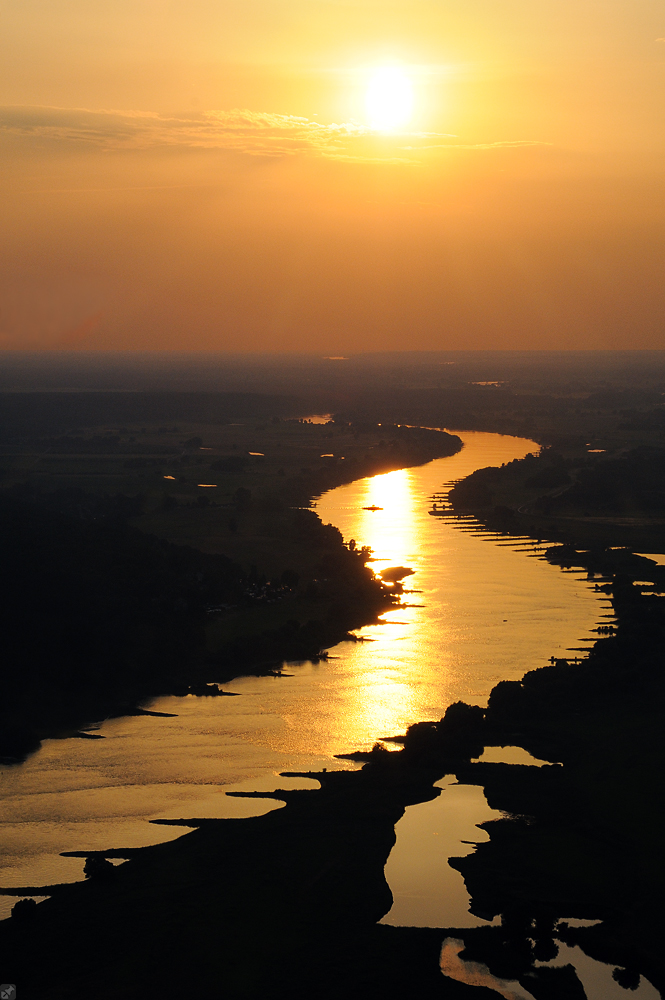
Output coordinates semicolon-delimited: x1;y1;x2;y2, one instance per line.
0;704;506;1000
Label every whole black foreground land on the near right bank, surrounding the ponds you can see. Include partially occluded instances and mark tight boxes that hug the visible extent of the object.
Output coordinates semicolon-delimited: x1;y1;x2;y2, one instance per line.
0;546;665;1000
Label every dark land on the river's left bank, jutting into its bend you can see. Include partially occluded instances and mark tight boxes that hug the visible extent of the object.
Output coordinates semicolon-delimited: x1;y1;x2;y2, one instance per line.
0;393;460;760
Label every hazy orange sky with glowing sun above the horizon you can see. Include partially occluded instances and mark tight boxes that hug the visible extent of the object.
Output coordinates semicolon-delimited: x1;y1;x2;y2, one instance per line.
0;0;665;354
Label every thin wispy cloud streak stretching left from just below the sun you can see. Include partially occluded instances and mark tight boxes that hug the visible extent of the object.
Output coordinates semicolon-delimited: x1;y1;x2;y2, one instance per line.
0;106;542;162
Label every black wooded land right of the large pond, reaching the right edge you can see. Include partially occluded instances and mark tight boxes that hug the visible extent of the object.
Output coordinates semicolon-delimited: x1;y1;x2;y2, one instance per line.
446;546;665;990
